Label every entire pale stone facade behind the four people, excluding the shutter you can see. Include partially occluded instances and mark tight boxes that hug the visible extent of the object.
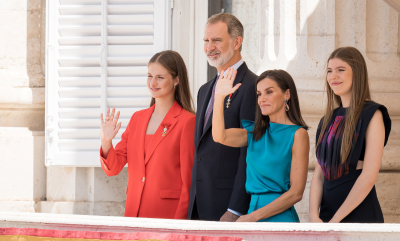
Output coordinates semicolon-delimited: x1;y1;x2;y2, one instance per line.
0;0;400;223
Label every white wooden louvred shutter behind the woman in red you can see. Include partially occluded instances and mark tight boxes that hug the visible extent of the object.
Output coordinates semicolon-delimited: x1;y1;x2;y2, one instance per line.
46;0;171;166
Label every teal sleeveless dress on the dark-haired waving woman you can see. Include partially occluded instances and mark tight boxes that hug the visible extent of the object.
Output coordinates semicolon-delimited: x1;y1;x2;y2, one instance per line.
242;120;301;222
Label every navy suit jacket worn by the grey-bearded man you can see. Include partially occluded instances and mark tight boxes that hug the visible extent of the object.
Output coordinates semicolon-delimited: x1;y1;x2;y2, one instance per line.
188;63;257;221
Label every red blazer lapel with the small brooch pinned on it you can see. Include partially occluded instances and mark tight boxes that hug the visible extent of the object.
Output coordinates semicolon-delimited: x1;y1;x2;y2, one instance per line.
145;101;182;165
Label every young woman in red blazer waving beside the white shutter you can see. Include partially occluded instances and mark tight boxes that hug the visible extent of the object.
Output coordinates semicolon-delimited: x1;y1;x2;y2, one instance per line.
100;51;195;219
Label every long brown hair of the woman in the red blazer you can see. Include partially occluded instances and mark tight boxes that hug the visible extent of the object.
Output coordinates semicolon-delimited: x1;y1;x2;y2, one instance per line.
147;50;195;114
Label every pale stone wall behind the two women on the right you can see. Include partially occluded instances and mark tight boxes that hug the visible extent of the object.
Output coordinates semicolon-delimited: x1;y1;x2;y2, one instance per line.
233;0;400;223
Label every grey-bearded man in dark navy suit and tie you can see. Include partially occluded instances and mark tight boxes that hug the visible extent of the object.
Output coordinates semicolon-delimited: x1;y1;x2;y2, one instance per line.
188;13;257;222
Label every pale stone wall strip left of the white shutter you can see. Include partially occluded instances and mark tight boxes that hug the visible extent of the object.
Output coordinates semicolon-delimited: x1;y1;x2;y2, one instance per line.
0;0;46;212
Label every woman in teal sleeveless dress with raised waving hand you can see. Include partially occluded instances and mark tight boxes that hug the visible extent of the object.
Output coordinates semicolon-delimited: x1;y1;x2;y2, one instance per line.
212;68;309;222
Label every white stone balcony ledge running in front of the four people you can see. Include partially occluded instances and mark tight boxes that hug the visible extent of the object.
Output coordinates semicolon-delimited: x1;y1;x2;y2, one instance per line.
0;212;400;241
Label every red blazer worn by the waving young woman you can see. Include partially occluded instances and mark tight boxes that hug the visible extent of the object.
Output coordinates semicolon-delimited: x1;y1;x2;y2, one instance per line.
100;101;195;219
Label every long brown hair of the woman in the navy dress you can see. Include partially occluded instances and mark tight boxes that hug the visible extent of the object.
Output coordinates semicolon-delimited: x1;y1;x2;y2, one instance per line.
316;47;371;164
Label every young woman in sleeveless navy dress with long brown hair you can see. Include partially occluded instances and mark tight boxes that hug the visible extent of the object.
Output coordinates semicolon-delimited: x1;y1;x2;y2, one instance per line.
309;47;391;223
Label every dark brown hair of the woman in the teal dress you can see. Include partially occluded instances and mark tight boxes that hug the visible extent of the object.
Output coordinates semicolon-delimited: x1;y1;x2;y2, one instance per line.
253;69;308;141
